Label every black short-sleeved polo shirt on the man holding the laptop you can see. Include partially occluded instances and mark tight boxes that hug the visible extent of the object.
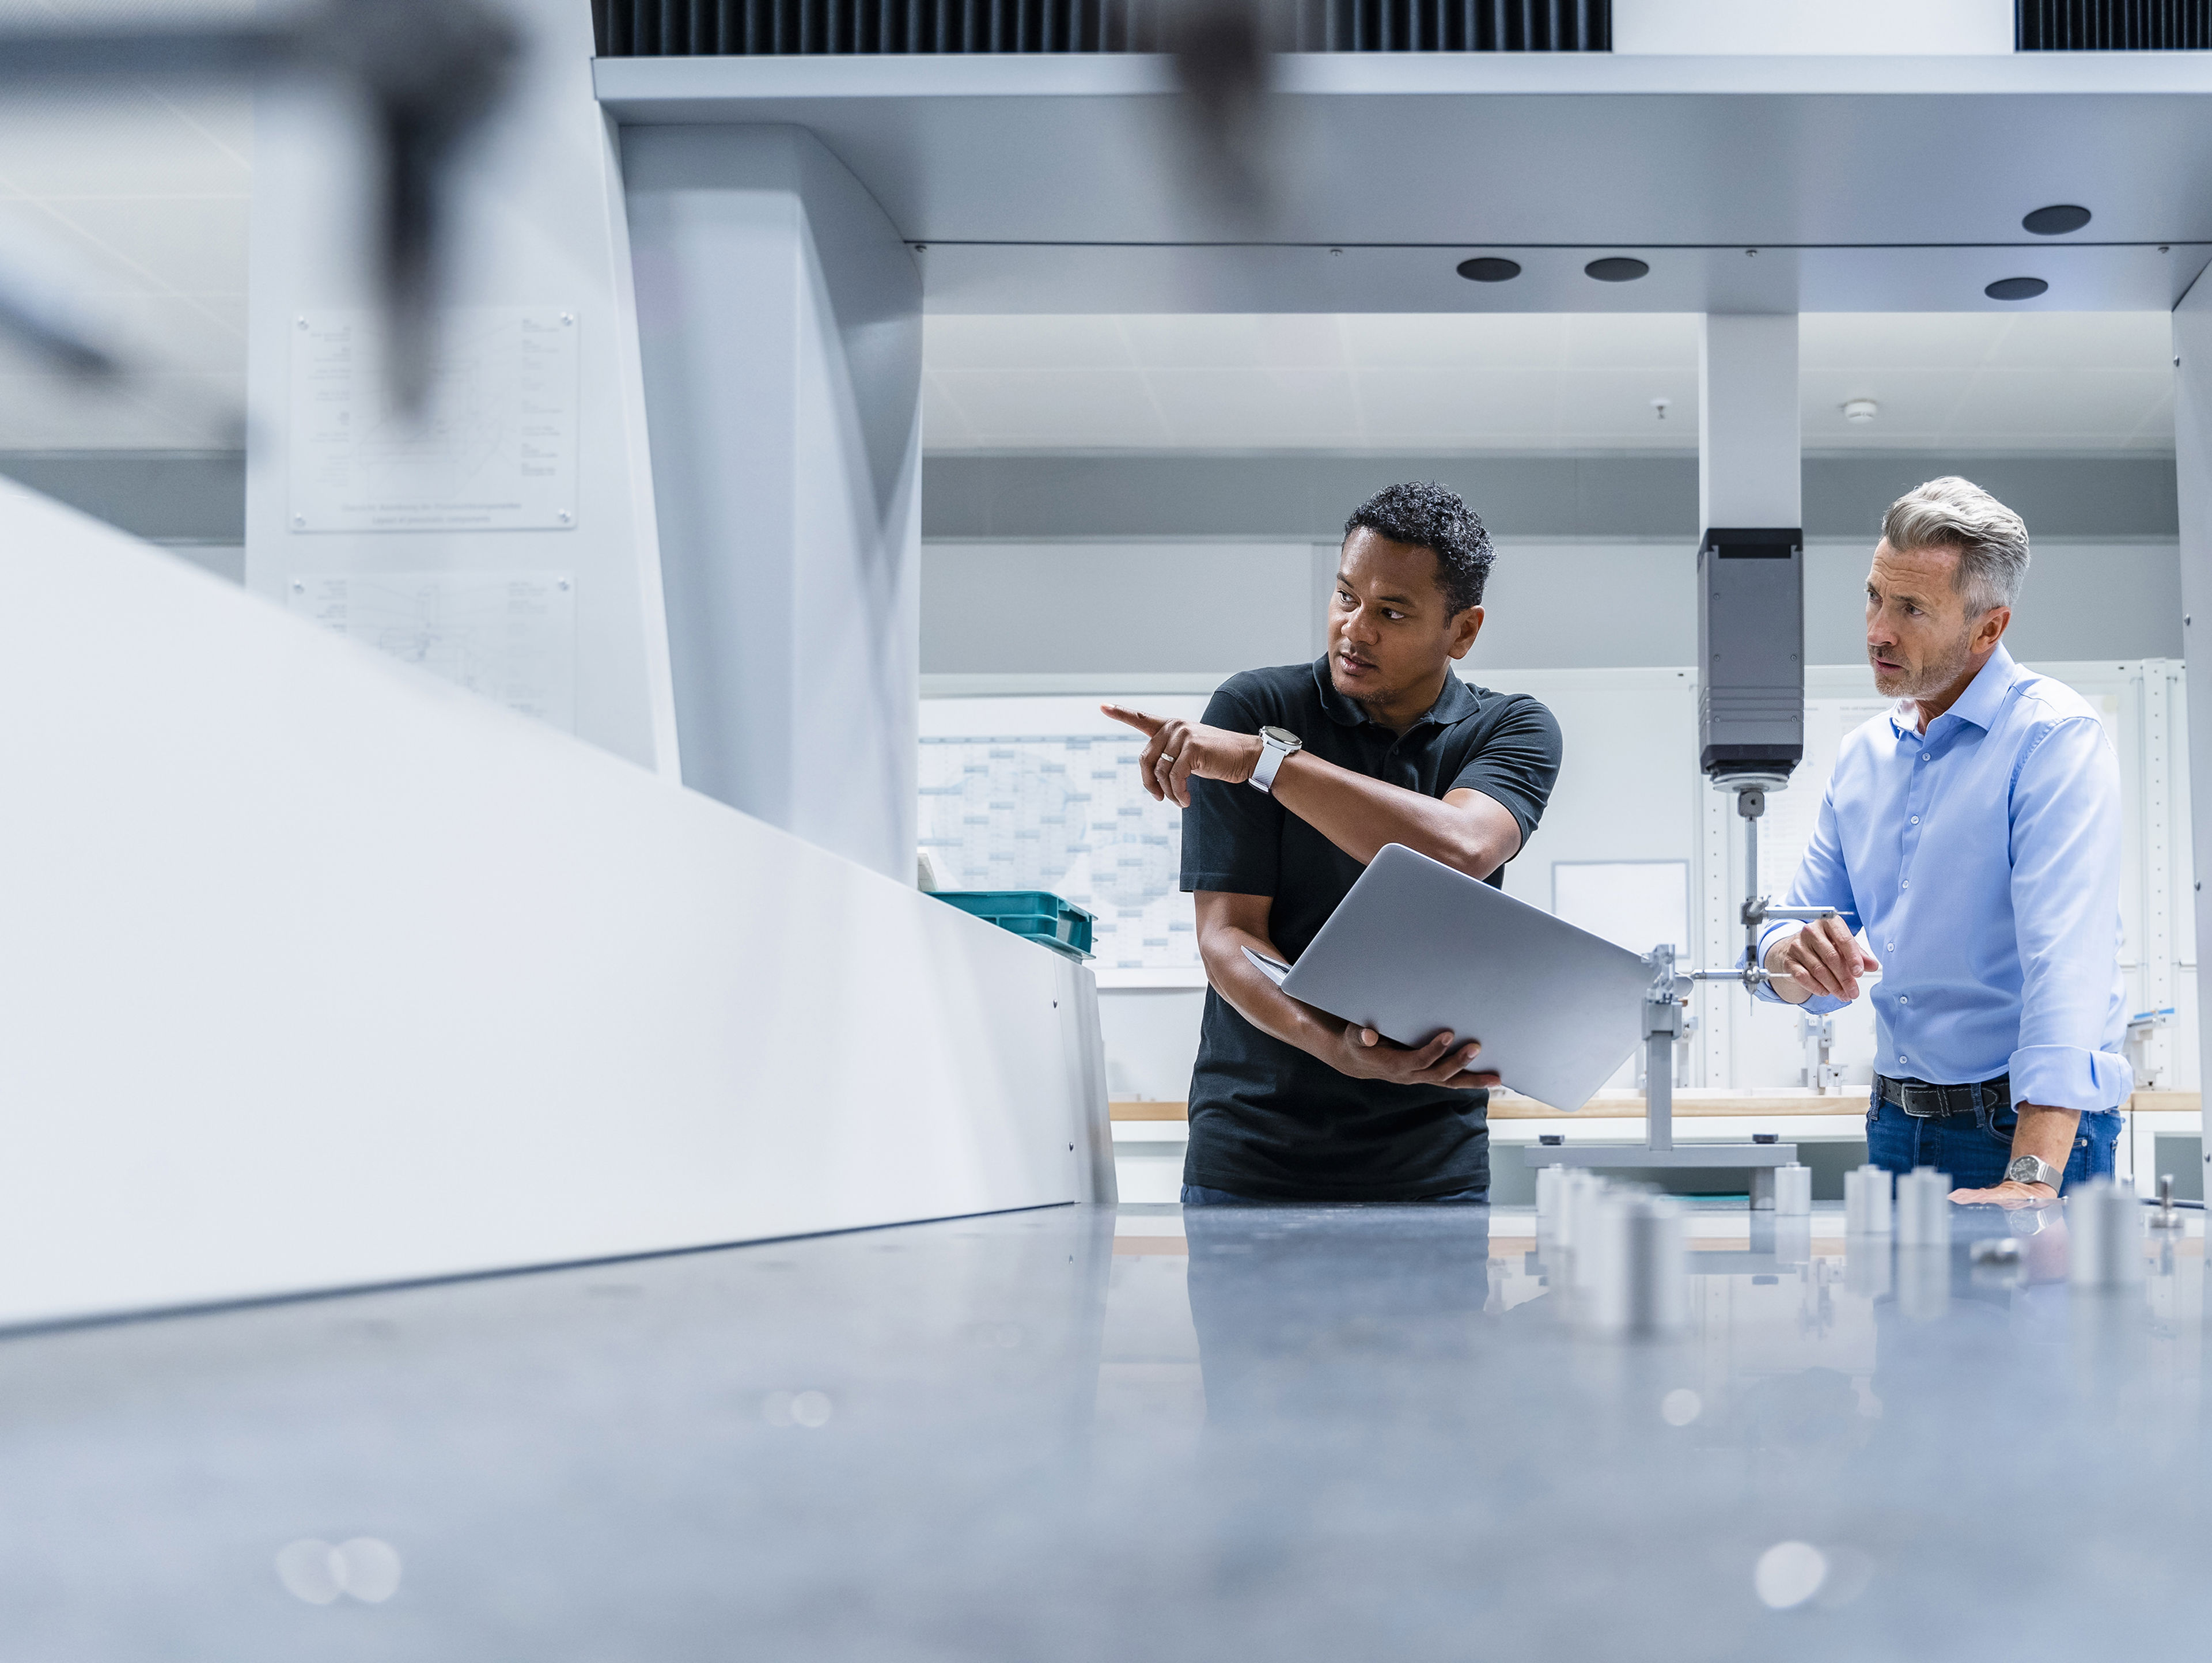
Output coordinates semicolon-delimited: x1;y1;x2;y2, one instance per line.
1183;657;1559;1201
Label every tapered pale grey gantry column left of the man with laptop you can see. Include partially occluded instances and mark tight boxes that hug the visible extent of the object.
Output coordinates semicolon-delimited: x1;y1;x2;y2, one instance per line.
624;126;922;876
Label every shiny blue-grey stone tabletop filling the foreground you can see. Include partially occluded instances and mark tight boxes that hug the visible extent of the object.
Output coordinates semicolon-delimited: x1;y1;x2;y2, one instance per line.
0;1203;2207;1661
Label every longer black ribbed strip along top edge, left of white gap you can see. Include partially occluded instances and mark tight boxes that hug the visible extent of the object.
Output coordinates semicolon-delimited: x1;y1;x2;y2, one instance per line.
593;0;1619;58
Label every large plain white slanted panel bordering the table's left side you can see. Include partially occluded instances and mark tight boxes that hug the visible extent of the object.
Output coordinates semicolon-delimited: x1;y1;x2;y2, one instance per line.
0;487;1104;1323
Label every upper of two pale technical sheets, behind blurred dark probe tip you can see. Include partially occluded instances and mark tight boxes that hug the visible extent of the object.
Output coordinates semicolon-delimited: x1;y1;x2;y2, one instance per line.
287;308;577;533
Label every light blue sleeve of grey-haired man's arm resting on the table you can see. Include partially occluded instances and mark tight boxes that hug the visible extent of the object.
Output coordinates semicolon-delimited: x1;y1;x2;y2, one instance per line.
2009;717;2135;1112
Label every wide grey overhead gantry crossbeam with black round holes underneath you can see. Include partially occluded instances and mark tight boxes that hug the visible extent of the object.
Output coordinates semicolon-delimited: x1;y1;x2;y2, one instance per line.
595;53;2212;312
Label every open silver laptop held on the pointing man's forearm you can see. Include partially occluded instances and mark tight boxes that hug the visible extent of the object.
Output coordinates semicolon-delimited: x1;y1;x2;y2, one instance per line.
1252;843;1652;1108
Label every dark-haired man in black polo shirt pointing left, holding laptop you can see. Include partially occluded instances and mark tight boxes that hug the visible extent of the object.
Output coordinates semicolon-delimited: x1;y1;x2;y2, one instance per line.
1106;484;1559;1205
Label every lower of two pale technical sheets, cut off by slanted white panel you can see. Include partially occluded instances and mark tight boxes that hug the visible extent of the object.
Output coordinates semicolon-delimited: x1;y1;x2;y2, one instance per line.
285;573;575;732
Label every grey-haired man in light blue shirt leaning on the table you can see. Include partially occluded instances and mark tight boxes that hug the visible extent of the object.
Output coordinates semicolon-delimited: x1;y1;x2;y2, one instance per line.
1761;480;2135;1205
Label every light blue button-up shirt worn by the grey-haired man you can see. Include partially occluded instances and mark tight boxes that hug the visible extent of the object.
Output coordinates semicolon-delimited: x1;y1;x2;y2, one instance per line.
1759;646;2135;1112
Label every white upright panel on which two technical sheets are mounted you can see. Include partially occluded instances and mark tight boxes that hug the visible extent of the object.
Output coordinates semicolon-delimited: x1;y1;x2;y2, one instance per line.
245;0;677;778
